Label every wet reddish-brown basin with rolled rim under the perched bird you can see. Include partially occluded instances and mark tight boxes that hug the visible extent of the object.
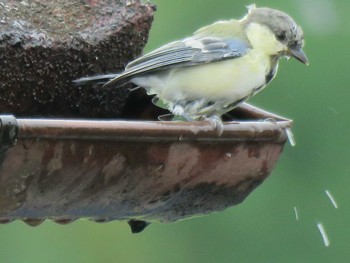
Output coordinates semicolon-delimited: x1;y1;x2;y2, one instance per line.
0;104;292;232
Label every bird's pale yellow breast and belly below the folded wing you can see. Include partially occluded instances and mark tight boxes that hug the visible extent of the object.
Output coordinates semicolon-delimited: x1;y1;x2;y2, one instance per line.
133;50;270;102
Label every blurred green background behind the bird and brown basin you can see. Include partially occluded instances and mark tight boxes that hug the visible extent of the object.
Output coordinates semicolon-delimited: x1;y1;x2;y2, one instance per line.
0;0;350;263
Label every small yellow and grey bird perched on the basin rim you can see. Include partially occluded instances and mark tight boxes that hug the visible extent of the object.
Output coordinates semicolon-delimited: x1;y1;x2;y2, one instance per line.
74;5;308;132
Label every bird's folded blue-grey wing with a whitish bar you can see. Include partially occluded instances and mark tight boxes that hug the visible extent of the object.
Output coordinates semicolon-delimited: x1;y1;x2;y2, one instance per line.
104;35;250;87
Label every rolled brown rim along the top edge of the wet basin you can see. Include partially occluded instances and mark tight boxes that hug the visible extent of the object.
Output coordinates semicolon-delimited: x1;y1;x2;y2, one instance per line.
0;104;292;142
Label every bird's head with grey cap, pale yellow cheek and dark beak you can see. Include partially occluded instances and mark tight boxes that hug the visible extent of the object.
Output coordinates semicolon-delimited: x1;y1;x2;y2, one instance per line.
241;5;308;64
